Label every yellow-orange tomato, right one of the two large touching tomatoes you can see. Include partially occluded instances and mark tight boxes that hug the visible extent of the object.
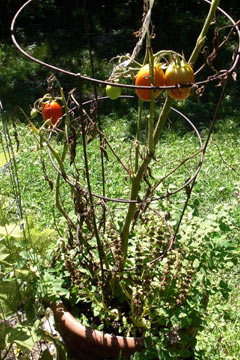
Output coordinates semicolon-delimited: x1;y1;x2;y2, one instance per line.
165;61;194;100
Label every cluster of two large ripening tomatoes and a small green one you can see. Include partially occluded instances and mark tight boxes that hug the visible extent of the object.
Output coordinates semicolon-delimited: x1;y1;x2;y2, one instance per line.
106;60;194;101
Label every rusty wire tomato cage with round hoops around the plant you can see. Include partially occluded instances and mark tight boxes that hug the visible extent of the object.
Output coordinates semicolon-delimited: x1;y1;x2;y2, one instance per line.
11;0;240;271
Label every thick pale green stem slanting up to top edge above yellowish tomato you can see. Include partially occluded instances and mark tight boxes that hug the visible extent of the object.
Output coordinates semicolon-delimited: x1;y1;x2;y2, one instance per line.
189;0;220;64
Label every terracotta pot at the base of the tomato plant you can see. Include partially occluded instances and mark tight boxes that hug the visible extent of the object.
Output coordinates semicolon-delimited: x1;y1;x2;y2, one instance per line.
52;304;145;360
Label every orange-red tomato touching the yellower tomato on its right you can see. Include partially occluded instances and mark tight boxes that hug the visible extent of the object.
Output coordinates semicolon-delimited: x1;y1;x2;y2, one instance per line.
135;64;165;101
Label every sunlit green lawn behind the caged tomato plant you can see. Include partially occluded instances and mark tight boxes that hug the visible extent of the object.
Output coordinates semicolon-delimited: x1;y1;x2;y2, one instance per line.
0;102;240;360
